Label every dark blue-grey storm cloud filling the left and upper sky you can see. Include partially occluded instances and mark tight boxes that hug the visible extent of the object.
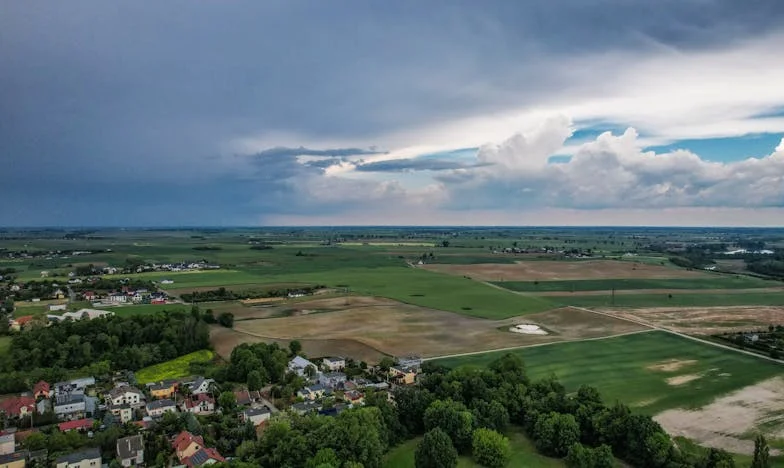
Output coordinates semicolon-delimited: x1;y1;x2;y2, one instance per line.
0;0;784;225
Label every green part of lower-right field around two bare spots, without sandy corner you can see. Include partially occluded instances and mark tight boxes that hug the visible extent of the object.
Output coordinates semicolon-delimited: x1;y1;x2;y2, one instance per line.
438;332;784;415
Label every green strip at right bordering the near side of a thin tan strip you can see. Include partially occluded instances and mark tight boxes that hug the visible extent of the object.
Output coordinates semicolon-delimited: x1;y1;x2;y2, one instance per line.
548;292;784;307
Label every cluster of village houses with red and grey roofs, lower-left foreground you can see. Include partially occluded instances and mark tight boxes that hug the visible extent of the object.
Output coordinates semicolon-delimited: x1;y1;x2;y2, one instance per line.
0;355;422;468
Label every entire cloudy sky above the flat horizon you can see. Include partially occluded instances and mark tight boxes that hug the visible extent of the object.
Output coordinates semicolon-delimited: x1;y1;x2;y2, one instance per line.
0;0;784;226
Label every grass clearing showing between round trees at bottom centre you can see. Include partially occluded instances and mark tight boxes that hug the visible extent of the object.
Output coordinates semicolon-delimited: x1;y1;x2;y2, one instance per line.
382;427;566;468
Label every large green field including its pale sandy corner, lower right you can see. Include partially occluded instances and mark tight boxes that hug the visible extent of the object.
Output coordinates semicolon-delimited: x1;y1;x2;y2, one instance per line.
437;331;784;453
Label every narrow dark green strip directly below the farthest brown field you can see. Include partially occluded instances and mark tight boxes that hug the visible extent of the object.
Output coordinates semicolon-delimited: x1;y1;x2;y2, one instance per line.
494;275;784;292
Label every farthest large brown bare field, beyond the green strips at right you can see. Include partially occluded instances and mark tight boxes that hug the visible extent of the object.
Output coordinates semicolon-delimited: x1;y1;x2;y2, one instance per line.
419;260;705;281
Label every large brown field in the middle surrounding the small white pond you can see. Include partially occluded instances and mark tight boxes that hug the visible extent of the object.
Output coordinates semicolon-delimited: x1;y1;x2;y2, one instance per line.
213;296;645;357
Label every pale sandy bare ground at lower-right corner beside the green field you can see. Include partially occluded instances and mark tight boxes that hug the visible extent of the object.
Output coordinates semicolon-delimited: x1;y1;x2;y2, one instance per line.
654;377;784;454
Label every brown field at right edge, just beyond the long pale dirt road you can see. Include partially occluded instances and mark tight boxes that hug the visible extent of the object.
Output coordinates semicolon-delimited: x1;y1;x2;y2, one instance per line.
597;306;784;335
